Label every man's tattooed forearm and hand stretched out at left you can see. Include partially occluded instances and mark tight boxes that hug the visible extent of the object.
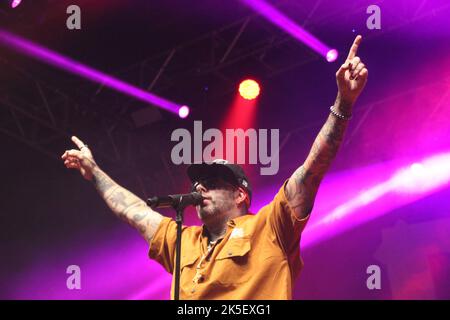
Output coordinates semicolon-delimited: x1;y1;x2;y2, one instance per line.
61;137;163;243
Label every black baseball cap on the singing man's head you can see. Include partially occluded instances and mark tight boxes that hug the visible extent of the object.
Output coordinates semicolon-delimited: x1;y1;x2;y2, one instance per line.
187;159;252;206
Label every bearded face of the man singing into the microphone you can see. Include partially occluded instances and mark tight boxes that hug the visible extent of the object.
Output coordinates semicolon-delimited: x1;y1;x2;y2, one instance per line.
194;178;237;220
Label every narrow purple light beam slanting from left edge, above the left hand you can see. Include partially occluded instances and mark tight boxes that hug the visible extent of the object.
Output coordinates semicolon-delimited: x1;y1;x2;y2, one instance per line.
0;30;189;118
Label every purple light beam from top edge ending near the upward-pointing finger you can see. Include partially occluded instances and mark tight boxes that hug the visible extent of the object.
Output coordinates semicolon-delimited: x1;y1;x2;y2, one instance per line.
241;0;338;62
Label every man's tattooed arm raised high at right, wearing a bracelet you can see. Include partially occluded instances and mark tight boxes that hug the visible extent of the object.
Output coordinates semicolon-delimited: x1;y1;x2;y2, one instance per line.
285;36;368;219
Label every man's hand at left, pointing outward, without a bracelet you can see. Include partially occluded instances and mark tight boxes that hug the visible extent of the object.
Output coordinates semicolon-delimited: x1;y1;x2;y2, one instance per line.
61;136;97;180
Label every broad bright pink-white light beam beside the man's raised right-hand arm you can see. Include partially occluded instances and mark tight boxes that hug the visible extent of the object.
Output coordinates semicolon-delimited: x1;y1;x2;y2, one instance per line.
302;152;450;246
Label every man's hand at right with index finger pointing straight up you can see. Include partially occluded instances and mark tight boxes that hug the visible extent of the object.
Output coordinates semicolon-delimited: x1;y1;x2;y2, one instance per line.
336;35;369;112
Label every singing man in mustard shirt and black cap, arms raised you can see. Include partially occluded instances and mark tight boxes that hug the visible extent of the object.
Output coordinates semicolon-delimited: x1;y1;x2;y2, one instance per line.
62;36;368;299
